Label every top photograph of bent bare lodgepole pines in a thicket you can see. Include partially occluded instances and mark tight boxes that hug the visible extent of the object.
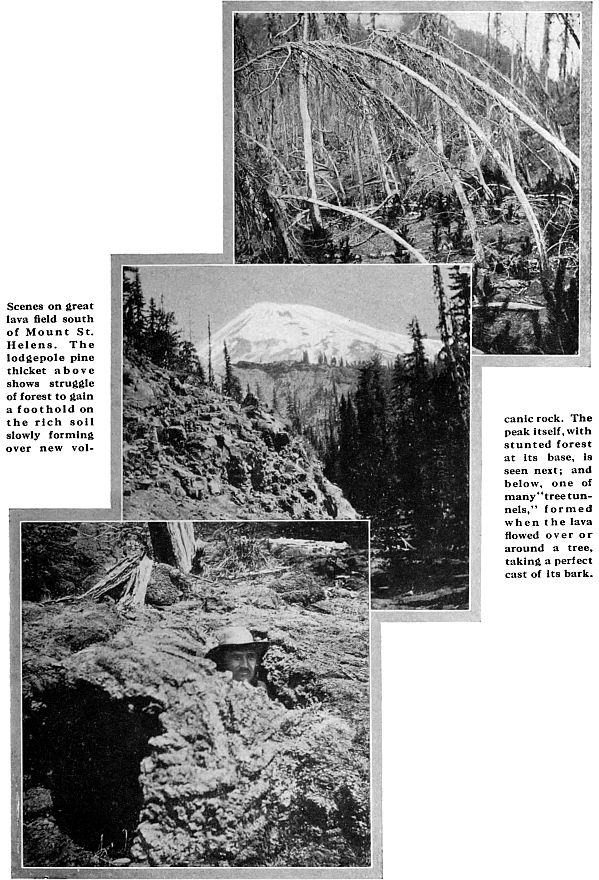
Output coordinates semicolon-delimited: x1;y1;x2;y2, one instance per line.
234;11;581;354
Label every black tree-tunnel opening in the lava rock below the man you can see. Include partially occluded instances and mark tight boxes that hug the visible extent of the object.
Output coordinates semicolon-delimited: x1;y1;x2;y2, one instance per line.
23;682;163;856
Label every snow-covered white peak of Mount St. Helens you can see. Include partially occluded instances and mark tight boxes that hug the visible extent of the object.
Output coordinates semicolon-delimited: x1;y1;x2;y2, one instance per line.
199;302;441;371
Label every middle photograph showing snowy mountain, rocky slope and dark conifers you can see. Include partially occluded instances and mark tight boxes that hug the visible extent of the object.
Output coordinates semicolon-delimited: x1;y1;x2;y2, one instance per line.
122;264;471;609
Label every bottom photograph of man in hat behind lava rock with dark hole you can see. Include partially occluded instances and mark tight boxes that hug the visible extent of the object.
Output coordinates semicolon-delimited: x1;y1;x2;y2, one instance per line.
15;521;373;876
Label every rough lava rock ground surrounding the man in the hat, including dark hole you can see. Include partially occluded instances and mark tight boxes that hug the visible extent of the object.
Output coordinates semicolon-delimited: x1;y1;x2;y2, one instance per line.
23;528;370;867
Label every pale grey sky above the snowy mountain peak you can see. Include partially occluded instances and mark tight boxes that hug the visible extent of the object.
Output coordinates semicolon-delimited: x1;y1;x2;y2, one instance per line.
140;264;464;345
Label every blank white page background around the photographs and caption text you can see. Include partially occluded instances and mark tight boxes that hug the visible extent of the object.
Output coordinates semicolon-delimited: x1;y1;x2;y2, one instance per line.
0;0;599;880
